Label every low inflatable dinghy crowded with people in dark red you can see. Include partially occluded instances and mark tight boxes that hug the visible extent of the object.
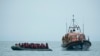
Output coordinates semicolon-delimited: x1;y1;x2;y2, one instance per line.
11;43;52;51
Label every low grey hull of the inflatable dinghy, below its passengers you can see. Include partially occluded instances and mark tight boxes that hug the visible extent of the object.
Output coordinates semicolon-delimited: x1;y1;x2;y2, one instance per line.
11;46;52;51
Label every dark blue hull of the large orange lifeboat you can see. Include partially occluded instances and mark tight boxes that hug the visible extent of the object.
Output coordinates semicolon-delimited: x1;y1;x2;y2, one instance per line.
62;40;91;50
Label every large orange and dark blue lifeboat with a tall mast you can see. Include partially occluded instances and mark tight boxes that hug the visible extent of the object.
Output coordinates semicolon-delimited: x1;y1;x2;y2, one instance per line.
62;15;91;50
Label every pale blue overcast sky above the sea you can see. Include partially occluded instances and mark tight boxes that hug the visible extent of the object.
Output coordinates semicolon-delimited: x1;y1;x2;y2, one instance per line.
0;0;100;41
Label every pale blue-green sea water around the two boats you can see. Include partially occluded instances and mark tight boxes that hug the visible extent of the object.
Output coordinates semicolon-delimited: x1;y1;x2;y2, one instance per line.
0;41;100;56
